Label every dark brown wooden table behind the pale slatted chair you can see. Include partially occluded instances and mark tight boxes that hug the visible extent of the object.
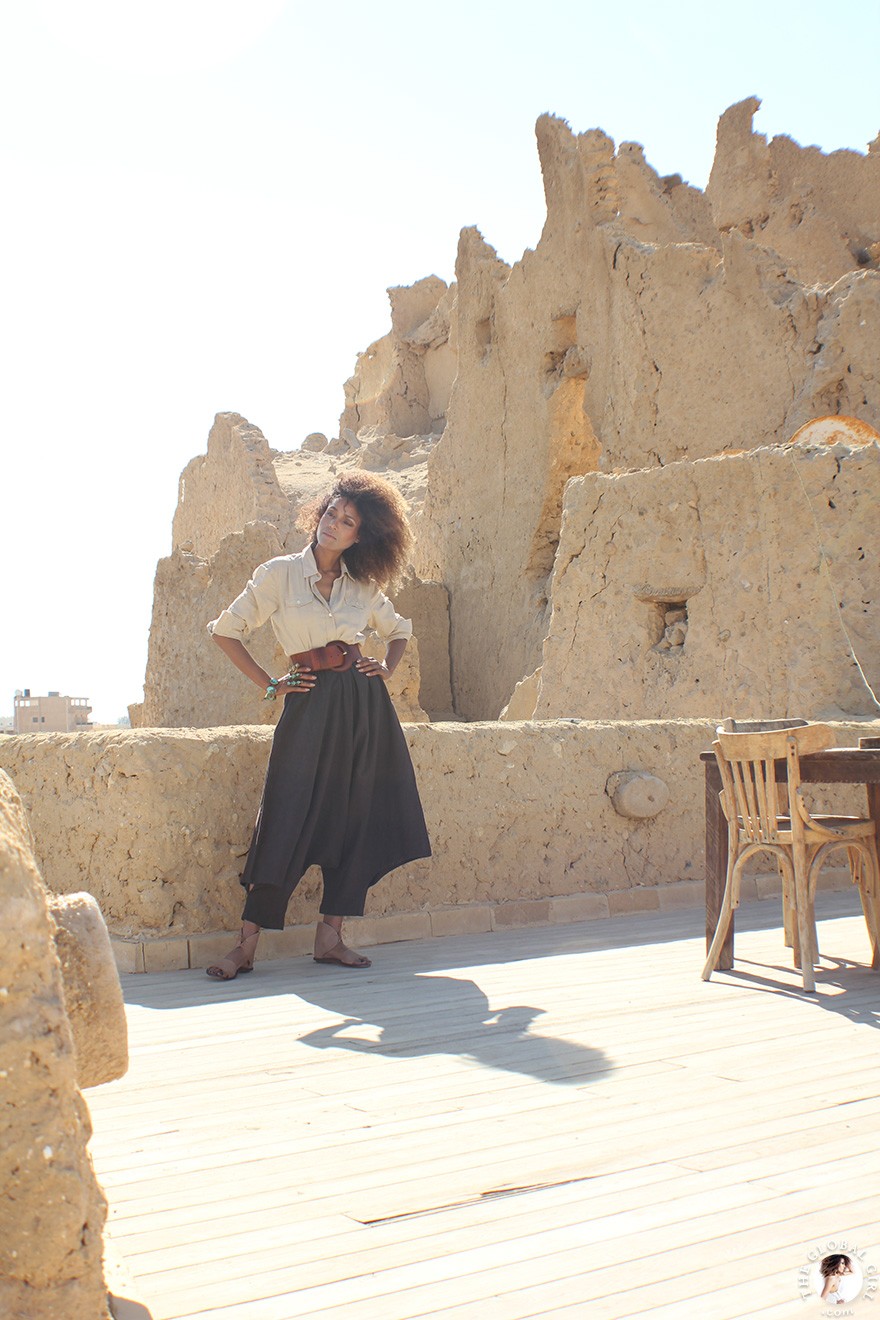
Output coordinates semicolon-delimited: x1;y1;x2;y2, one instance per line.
699;747;880;972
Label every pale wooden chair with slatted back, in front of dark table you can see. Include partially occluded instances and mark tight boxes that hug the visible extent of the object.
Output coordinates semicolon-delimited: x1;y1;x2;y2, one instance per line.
703;725;880;991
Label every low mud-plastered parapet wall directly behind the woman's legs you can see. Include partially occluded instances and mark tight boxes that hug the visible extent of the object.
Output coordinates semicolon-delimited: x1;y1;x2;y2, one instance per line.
0;719;880;972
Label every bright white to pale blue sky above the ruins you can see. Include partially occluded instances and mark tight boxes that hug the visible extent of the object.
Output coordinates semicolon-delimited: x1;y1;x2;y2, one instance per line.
0;0;880;722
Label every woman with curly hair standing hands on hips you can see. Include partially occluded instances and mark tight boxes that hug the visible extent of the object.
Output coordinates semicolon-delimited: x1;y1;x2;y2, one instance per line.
207;473;430;981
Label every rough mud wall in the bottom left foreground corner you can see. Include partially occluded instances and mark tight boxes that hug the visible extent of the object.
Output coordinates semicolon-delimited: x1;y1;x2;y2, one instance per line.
0;772;107;1320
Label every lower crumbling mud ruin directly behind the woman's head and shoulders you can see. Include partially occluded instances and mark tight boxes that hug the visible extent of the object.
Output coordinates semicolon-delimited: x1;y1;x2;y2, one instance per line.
139;411;453;727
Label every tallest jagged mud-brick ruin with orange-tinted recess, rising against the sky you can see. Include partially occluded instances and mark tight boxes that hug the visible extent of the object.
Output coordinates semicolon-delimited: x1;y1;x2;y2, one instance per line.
417;112;880;718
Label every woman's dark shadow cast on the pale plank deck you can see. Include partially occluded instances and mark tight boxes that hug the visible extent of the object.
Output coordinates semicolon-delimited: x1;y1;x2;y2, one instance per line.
296;972;613;1086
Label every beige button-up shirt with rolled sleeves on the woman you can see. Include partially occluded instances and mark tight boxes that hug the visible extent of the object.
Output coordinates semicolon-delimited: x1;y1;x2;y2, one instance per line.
207;545;413;656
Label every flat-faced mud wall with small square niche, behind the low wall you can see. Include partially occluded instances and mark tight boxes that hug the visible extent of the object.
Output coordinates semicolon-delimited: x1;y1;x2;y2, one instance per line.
534;444;880;719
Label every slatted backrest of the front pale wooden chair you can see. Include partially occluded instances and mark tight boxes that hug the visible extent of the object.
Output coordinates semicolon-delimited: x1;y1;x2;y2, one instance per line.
712;725;834;843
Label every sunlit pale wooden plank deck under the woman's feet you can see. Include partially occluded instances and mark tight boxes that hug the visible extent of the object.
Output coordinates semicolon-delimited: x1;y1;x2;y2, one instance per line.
88;892;880;1320
